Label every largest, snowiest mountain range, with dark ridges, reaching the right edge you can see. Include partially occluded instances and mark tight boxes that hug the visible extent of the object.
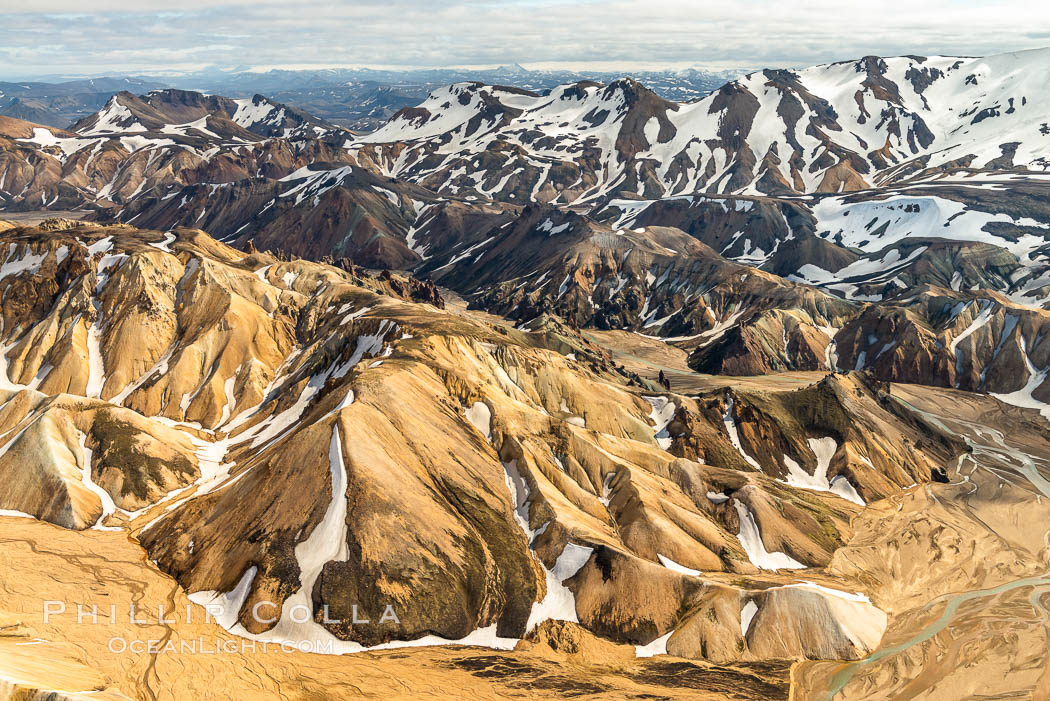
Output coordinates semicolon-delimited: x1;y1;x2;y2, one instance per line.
358;49;1050;204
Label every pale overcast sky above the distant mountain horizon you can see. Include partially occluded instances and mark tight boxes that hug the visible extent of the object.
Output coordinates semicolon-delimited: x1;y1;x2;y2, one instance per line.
0;0;1050;79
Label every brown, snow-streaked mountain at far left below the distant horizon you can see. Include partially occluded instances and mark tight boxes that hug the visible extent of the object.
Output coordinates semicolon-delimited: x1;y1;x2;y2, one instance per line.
0;90;350;210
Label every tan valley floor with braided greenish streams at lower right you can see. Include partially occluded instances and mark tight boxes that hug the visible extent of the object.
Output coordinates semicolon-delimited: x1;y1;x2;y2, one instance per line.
792;385;1050;701
